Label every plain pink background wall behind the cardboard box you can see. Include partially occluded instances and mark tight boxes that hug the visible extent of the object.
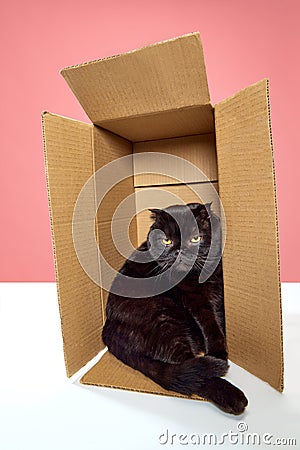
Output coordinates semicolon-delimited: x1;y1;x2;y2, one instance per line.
0;0;300;281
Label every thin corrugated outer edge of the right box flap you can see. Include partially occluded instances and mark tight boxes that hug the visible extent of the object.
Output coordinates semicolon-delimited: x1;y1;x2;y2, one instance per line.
265;78;284;392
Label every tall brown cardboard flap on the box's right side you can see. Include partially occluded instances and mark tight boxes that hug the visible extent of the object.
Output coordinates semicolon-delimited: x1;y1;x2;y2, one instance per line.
215;80;283;391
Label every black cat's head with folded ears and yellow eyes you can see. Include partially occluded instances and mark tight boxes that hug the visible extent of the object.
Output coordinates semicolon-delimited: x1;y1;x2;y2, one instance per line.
147;203;220;273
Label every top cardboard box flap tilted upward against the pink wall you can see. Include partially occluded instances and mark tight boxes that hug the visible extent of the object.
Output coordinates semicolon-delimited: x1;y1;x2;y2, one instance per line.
61;33;210;125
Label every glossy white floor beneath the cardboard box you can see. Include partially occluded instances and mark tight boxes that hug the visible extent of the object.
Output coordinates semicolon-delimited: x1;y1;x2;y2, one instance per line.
0;283;300;450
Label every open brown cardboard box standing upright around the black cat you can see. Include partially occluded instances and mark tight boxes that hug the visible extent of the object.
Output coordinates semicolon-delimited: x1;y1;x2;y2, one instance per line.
42;33;283;396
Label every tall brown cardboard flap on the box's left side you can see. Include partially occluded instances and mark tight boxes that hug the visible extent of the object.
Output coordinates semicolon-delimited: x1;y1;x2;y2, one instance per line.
42;113;103;376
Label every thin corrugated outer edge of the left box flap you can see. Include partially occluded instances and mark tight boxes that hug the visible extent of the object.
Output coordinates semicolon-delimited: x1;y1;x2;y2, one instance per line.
41;111;73;377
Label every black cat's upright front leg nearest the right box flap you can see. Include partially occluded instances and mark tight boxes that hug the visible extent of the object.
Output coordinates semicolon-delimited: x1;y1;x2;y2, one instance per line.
184;297;228;360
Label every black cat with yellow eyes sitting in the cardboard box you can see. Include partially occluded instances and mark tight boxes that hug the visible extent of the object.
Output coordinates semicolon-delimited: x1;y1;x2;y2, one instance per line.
102;203;248;414
